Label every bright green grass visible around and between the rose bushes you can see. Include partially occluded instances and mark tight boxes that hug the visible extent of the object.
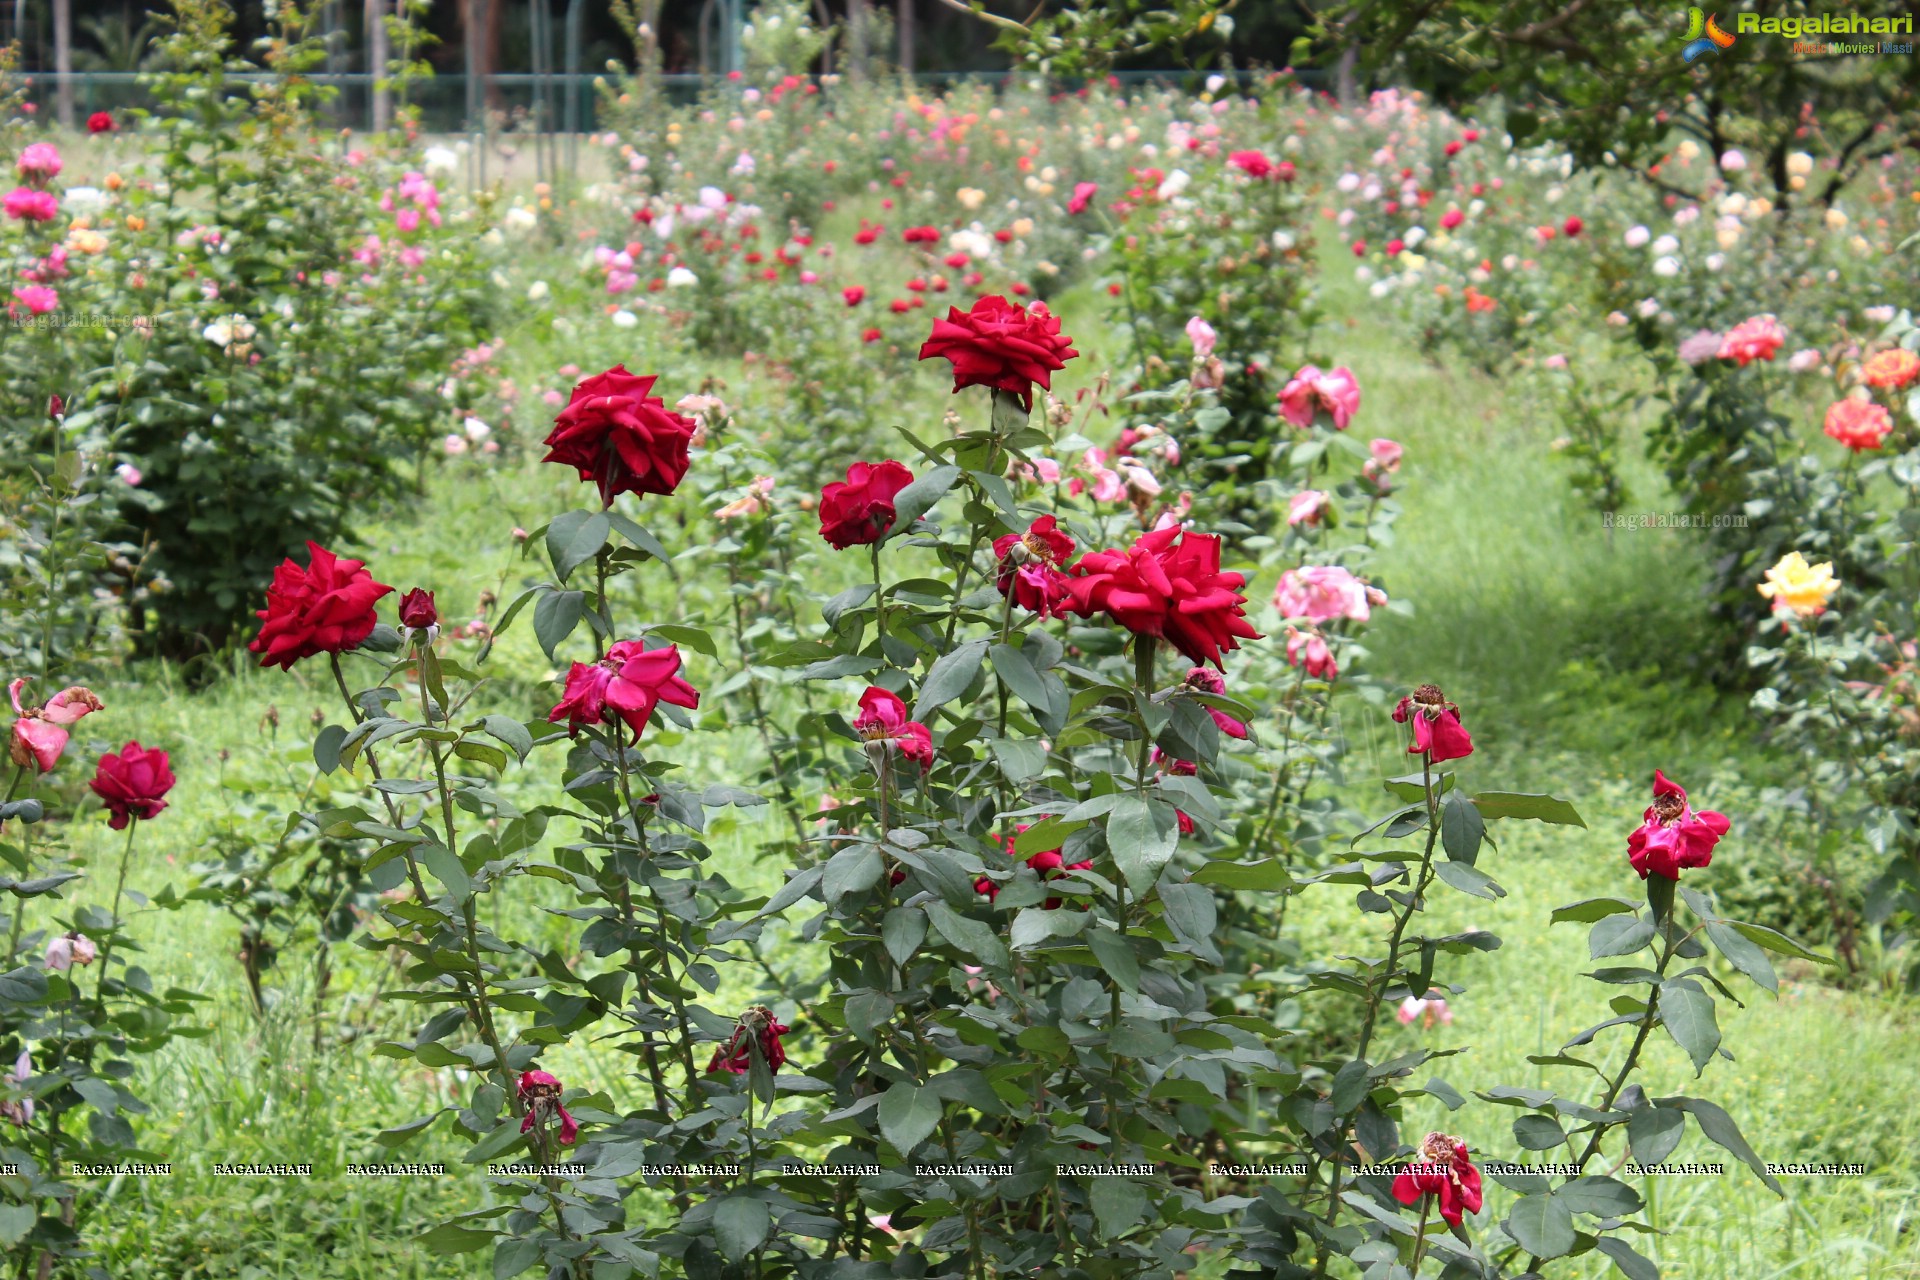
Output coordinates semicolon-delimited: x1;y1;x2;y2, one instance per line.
18;213;1920;1280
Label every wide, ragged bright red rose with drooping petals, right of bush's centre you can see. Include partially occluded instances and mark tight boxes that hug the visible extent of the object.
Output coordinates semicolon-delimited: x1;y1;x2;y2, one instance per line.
1071;526;1260;666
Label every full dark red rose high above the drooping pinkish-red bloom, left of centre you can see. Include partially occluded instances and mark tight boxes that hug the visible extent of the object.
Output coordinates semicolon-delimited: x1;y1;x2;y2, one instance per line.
541;365;693;507
